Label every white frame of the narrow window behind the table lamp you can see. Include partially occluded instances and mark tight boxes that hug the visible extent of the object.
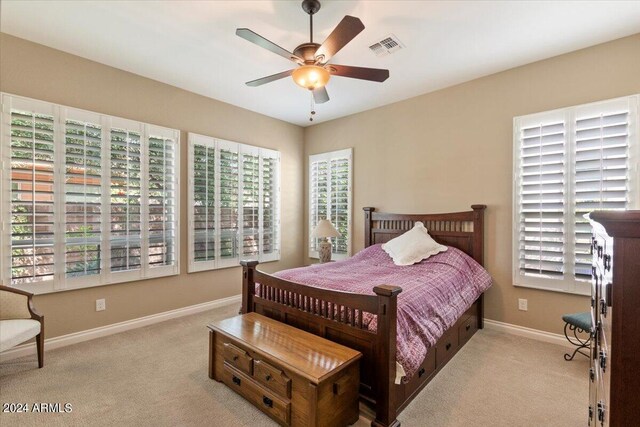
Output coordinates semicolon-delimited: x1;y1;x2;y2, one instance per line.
307;148;353;260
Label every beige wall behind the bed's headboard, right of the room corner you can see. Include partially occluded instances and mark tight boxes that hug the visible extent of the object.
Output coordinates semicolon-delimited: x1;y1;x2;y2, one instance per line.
305;34;640;333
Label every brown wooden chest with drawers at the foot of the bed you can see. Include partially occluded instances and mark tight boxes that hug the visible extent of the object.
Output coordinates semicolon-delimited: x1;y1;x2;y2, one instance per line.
209;313;362;427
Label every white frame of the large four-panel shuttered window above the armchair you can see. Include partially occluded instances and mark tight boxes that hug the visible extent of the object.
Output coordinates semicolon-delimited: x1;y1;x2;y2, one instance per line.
0;92;180;294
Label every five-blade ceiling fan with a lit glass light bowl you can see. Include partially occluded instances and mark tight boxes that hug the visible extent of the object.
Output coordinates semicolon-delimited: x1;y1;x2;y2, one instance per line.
236;0;389;104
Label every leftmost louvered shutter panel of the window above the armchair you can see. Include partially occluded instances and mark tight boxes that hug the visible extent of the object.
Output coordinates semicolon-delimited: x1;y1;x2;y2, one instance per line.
3;100;58;285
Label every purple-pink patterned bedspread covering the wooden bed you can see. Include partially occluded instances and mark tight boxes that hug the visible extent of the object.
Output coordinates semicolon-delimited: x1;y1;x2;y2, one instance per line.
275;245;491;379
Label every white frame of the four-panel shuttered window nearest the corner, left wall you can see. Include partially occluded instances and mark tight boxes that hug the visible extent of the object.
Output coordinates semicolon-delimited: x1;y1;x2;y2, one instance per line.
187;132;282;273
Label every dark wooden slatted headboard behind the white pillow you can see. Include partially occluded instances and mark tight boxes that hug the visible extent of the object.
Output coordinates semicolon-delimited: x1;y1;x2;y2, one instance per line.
363;205;487;265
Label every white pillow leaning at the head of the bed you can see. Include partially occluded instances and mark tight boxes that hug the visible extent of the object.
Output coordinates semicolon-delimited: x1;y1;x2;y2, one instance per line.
382;222;447;265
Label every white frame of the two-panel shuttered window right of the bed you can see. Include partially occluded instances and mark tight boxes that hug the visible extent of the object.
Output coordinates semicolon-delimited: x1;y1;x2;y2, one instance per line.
512;95;640;295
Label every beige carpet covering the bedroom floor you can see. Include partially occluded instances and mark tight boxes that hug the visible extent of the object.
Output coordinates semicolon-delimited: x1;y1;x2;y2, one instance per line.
0;306;588;427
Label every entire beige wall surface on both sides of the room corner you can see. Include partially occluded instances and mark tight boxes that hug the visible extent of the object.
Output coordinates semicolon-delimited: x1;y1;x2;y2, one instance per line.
0;34;640;337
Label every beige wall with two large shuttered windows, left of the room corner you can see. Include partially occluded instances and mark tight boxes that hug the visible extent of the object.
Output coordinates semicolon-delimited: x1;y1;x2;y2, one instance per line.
0;34;303;338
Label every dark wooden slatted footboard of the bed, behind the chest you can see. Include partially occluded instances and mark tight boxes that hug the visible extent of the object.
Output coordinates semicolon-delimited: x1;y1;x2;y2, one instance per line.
242;261;402;426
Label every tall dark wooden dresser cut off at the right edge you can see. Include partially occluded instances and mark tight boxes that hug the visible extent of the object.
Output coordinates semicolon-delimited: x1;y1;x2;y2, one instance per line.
589;211;640;427
